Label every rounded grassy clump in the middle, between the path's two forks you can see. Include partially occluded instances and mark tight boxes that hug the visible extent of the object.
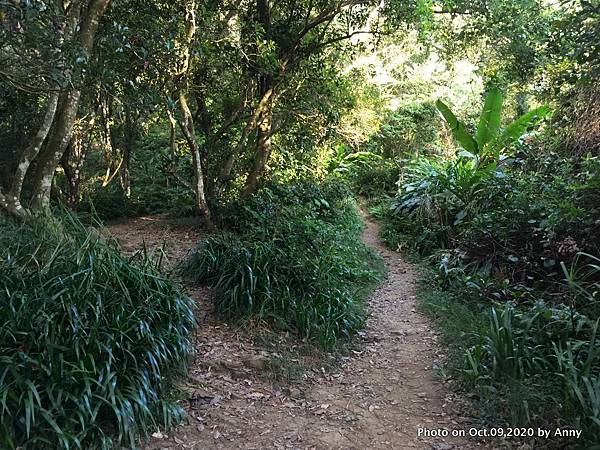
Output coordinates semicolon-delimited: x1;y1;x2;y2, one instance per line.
186;179;381;349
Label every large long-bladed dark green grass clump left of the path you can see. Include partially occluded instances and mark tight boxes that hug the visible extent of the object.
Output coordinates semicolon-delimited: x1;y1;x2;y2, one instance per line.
0;213;195;449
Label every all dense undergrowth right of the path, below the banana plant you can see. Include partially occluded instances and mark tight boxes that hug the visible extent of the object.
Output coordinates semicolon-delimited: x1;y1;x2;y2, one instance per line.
373;145;600;448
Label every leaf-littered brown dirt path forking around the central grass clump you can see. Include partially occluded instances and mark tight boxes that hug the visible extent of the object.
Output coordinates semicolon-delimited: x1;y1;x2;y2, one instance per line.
109;216;482;450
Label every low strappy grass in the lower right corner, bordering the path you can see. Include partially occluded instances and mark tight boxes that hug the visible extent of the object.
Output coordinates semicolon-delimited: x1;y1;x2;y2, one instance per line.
420;264;600;442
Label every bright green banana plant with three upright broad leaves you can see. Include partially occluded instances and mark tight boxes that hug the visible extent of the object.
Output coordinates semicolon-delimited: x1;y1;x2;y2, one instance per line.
436;87;550;162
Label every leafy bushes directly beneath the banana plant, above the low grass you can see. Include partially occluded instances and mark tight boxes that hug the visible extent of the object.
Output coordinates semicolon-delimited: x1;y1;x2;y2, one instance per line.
385;151;600;284
